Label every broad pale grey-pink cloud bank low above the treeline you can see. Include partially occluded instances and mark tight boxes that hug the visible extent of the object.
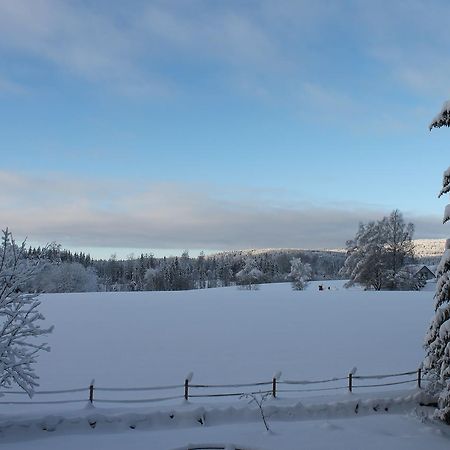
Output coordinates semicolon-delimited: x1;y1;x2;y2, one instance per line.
0;172;442;249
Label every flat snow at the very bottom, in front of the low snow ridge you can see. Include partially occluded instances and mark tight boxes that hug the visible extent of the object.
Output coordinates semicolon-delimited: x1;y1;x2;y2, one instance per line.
1;415;449;450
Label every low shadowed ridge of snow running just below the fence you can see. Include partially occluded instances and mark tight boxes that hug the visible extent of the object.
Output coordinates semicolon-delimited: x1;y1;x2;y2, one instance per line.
0;390;435;436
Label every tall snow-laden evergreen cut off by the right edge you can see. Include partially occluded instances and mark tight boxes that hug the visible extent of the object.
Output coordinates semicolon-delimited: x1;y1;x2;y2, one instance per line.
424;102;450;425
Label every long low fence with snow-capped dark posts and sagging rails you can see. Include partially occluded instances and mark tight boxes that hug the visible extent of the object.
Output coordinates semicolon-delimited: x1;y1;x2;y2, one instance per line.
0;369;428;405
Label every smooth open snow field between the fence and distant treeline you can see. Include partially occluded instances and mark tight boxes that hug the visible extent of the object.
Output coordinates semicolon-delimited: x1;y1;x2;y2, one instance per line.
20;281;433;398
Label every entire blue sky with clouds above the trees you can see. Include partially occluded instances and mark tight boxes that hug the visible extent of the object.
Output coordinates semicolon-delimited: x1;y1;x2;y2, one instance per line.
0;0;450;257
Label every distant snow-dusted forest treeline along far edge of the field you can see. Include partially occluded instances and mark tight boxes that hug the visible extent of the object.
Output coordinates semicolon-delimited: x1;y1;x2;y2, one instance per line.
24;246;345;292
